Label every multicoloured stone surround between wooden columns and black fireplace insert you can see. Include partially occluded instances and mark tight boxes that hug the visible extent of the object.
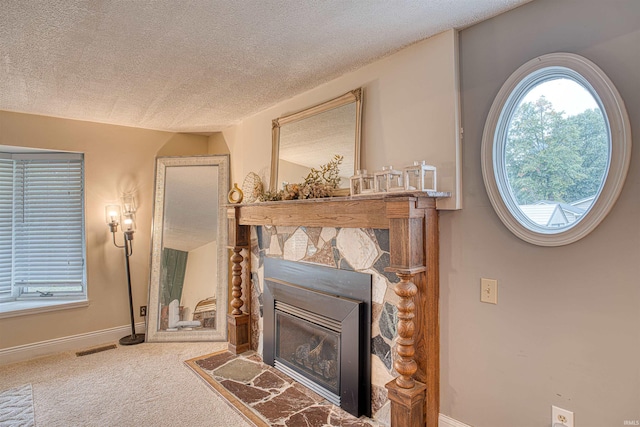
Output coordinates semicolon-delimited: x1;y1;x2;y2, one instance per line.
251;226;399;425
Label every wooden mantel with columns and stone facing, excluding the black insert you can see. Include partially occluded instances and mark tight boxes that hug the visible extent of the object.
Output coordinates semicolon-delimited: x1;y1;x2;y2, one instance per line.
227;196;442;427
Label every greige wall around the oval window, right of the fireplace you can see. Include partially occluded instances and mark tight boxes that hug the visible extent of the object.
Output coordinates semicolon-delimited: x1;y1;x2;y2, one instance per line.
440;0;640;427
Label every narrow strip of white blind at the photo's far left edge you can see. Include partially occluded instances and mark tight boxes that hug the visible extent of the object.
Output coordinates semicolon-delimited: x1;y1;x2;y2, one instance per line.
0;159;13;300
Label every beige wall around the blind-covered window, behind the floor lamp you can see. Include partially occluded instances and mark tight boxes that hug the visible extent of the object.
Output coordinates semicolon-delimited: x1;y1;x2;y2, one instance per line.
0;111;208;349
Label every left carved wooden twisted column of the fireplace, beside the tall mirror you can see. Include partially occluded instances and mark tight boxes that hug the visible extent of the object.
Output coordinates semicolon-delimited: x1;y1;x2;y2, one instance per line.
227;207;251;354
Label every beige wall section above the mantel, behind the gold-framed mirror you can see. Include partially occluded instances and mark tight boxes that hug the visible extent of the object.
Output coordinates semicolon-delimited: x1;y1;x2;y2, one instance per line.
223;30;461;209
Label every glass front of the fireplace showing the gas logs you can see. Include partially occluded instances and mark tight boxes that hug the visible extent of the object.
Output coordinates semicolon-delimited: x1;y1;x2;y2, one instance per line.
275;311;340;395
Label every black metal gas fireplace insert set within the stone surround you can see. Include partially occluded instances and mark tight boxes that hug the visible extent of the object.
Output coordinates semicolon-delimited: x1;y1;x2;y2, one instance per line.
263;258;371;416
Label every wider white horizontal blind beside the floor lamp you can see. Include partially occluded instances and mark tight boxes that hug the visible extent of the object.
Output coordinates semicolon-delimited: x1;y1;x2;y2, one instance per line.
13;159;84;289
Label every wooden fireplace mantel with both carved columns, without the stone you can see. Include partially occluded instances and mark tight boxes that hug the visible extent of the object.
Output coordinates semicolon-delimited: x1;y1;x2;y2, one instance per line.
227;192;450;427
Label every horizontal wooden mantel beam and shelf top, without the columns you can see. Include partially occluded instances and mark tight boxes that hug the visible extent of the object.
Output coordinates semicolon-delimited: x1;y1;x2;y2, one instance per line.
229;192;450;228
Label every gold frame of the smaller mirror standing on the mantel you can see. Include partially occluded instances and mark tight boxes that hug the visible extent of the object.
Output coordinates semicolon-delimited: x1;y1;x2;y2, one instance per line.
270;88;362;196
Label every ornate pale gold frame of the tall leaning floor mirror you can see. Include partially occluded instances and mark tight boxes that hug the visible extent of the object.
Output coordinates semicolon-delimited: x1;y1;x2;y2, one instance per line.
146;154;229;342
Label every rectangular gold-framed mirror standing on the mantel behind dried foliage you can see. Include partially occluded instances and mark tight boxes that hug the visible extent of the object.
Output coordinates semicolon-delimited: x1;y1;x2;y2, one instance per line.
271;88;362;194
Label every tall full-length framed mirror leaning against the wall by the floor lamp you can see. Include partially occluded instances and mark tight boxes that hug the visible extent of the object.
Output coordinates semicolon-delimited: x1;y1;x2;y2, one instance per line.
147;155;229;342
